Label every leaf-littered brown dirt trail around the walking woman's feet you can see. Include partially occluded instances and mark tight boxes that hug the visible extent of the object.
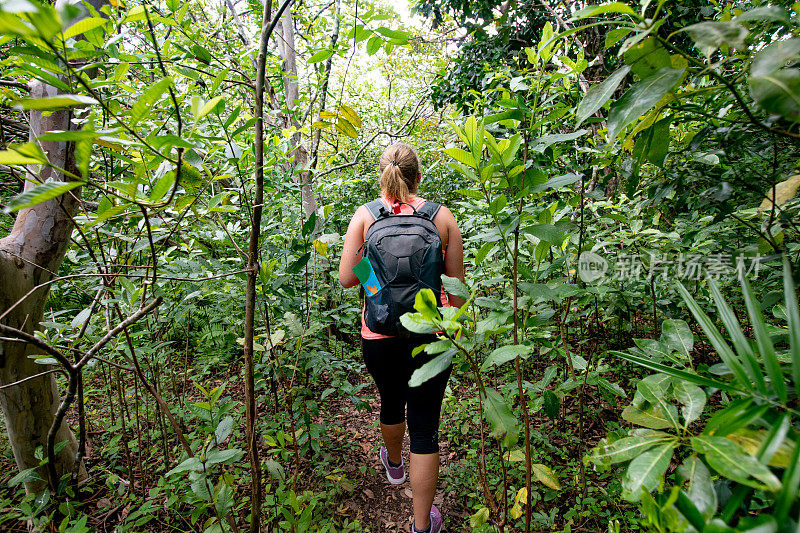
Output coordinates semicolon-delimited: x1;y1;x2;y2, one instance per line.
327;390;470;533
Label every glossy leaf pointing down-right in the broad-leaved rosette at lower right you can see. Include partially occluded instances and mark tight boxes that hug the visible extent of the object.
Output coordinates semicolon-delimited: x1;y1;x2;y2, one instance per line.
692;435;781;491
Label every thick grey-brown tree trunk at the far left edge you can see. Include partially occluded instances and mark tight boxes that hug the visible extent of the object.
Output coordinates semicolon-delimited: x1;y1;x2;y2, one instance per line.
0;82;85;492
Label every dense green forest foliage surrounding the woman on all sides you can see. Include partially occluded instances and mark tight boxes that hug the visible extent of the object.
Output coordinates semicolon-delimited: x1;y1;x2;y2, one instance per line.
0;0;800;533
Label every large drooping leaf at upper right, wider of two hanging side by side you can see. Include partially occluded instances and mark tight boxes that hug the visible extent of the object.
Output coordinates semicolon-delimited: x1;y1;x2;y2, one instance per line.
608;67;686;142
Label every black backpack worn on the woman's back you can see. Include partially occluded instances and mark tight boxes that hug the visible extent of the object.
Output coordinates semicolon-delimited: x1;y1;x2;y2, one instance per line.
363;199;444;337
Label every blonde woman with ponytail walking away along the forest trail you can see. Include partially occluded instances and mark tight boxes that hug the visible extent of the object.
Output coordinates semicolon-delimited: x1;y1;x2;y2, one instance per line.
339;144;464;533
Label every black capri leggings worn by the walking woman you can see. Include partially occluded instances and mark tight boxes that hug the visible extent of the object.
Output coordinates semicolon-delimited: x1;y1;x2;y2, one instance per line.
362;335;452;454
